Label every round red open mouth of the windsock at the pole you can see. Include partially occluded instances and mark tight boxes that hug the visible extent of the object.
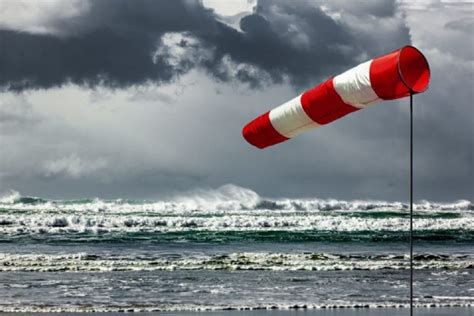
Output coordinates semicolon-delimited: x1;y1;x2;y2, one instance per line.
398;46;430;93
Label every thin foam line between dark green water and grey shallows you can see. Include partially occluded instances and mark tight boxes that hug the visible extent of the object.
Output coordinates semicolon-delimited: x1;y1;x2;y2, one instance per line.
0;252;474;272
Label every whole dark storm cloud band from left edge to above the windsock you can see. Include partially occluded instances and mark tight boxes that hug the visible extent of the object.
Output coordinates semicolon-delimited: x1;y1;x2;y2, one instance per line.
0;0;409;90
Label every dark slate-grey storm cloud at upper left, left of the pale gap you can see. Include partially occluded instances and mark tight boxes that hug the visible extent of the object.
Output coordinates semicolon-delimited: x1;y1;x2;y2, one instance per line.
0;0;212;90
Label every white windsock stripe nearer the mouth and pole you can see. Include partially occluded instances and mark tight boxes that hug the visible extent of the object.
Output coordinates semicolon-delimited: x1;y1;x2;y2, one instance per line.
332;60;379;109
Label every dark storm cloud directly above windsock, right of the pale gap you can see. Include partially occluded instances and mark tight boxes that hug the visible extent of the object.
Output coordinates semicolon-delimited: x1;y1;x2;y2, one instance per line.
200;1;361;85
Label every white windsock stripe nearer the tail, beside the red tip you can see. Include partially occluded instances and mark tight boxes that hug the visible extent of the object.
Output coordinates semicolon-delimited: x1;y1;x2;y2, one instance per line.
269;95;320;138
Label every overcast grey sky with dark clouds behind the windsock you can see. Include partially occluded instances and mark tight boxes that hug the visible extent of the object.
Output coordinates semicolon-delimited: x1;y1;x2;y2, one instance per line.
0;0;474;201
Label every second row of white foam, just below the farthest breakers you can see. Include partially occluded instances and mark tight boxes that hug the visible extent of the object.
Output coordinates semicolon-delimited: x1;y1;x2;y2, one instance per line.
0;212;474;234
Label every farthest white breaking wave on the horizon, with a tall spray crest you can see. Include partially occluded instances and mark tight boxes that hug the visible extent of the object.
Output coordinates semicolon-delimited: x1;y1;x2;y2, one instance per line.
0;184;474;213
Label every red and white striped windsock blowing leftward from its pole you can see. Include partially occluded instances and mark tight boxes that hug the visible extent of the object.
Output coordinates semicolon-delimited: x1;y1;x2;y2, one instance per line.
242;46;430;148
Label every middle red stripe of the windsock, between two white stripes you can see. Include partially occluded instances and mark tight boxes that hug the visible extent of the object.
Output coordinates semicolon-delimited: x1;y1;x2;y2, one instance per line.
301;78;359;125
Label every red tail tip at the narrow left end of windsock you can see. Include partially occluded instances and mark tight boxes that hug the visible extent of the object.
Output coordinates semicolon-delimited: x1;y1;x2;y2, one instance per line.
242;112;288;149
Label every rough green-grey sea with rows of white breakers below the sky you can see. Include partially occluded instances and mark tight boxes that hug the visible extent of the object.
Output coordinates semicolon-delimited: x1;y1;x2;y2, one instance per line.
0;185;474;312
